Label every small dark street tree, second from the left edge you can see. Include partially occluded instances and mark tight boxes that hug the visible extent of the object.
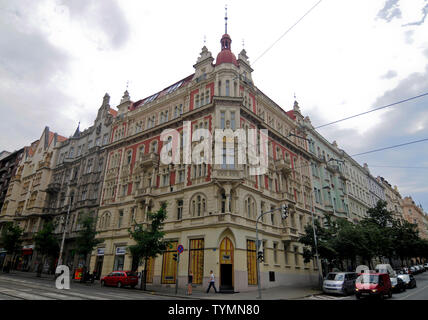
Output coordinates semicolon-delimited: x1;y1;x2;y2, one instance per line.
34;220;59;277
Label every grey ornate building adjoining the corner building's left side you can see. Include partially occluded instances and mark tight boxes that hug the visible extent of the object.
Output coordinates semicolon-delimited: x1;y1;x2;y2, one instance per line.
47;94;116;268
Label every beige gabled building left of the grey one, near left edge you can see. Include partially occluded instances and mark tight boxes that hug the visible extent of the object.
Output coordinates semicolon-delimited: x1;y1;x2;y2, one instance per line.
0;127;66;270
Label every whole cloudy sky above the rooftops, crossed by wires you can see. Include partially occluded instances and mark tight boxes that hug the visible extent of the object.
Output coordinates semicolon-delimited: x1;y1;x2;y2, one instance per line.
0;0;428;211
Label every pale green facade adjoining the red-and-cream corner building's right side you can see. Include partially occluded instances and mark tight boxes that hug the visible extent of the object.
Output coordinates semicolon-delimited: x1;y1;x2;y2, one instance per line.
305;117;351;220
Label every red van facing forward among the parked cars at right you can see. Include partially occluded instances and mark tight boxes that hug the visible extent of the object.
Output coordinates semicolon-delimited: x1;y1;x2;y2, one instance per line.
355;273;392;299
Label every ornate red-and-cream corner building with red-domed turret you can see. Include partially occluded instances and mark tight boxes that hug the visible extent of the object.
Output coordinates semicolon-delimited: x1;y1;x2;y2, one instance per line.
90;34;318;291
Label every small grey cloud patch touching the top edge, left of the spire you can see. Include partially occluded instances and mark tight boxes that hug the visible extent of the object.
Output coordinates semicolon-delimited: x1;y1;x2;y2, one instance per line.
58;0;130;49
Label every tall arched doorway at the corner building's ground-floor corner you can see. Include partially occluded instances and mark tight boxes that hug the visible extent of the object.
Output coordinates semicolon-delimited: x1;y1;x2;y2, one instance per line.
220;237;234;292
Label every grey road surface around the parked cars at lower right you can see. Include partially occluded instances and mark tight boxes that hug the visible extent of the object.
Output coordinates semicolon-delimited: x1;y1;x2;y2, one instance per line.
305;272;428;300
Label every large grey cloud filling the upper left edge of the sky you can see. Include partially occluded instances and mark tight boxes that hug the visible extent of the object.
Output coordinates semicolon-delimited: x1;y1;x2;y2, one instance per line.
0;1;72;150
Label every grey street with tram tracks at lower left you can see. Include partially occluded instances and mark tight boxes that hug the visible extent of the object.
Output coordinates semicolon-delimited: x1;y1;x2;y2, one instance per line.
0;275;189;300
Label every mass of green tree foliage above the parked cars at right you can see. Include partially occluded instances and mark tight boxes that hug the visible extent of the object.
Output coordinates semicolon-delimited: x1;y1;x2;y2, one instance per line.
299;201;428;268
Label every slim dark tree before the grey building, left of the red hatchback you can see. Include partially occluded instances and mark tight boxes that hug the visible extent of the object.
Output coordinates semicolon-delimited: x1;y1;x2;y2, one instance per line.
76;214;104;282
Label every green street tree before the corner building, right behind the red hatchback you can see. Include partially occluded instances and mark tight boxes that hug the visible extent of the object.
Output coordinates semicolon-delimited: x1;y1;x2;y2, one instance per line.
128;203;169;290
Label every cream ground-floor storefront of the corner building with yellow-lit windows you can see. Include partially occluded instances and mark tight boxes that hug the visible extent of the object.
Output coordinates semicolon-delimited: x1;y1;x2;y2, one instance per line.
90;227;318;292
